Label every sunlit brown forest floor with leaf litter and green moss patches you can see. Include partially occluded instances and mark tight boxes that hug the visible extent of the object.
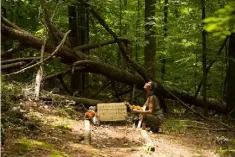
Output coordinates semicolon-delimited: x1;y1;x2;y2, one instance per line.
1;100;235;157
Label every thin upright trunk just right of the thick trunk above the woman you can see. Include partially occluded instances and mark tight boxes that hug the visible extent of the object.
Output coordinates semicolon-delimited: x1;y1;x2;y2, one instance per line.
161;0;168;80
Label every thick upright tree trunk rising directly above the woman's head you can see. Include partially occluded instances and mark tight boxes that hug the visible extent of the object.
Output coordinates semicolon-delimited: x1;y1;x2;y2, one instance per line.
144;0;157;77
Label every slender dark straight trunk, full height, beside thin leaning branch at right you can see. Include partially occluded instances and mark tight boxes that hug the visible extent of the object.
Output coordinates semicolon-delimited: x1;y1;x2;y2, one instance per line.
201;0;208;116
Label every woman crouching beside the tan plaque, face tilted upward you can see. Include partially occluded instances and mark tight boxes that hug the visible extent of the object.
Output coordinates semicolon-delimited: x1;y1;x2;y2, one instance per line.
133;81;163;132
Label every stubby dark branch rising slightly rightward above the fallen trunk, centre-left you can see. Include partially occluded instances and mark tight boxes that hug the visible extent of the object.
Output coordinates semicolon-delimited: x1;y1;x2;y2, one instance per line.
73;38;128;51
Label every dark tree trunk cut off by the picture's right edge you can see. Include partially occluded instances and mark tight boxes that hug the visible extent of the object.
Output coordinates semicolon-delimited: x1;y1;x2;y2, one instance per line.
226;33;235;112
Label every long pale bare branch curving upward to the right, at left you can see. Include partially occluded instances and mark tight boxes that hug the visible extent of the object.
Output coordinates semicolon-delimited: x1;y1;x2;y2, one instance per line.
3;30;70;76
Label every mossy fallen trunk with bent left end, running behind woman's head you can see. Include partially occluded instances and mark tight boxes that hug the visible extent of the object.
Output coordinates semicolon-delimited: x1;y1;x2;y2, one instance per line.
45;60;224;113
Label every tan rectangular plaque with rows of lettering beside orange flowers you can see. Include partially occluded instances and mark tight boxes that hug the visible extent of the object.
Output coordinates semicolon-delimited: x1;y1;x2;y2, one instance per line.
97;102;127;122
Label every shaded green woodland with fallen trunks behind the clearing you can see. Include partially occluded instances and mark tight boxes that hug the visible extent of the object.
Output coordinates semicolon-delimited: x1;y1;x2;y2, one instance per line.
1;0;235;115
